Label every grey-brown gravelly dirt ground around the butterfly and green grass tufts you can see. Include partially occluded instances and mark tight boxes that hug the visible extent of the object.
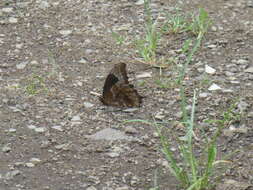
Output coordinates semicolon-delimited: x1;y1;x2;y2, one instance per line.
0;0;253;190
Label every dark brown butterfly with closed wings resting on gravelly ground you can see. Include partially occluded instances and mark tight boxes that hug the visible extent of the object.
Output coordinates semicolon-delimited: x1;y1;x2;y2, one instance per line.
100;63;143;107
